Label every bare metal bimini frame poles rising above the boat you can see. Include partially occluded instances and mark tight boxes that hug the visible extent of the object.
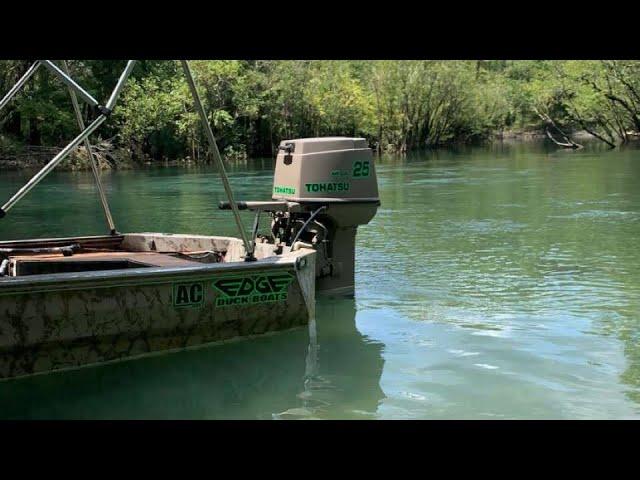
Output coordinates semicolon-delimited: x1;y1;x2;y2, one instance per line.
0;60;255;261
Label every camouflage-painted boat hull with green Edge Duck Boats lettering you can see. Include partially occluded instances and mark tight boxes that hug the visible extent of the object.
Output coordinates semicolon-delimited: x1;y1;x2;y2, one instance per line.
0;234;315;378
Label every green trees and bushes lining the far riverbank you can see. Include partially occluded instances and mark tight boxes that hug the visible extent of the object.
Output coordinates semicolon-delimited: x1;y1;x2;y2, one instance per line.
0;60;640;170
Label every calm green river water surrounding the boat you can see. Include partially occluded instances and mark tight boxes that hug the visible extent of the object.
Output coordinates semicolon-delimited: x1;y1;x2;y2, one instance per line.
0;145;640;419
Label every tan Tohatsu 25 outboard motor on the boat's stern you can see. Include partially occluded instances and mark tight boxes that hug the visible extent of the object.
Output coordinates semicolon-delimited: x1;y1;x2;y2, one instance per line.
221;137;380;294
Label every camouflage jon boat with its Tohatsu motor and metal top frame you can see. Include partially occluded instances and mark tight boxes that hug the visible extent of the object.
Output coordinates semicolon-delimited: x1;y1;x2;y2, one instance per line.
0;60;380;378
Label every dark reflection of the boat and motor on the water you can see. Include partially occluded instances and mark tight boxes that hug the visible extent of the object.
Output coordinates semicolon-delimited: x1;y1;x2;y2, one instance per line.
0;299;384;419
